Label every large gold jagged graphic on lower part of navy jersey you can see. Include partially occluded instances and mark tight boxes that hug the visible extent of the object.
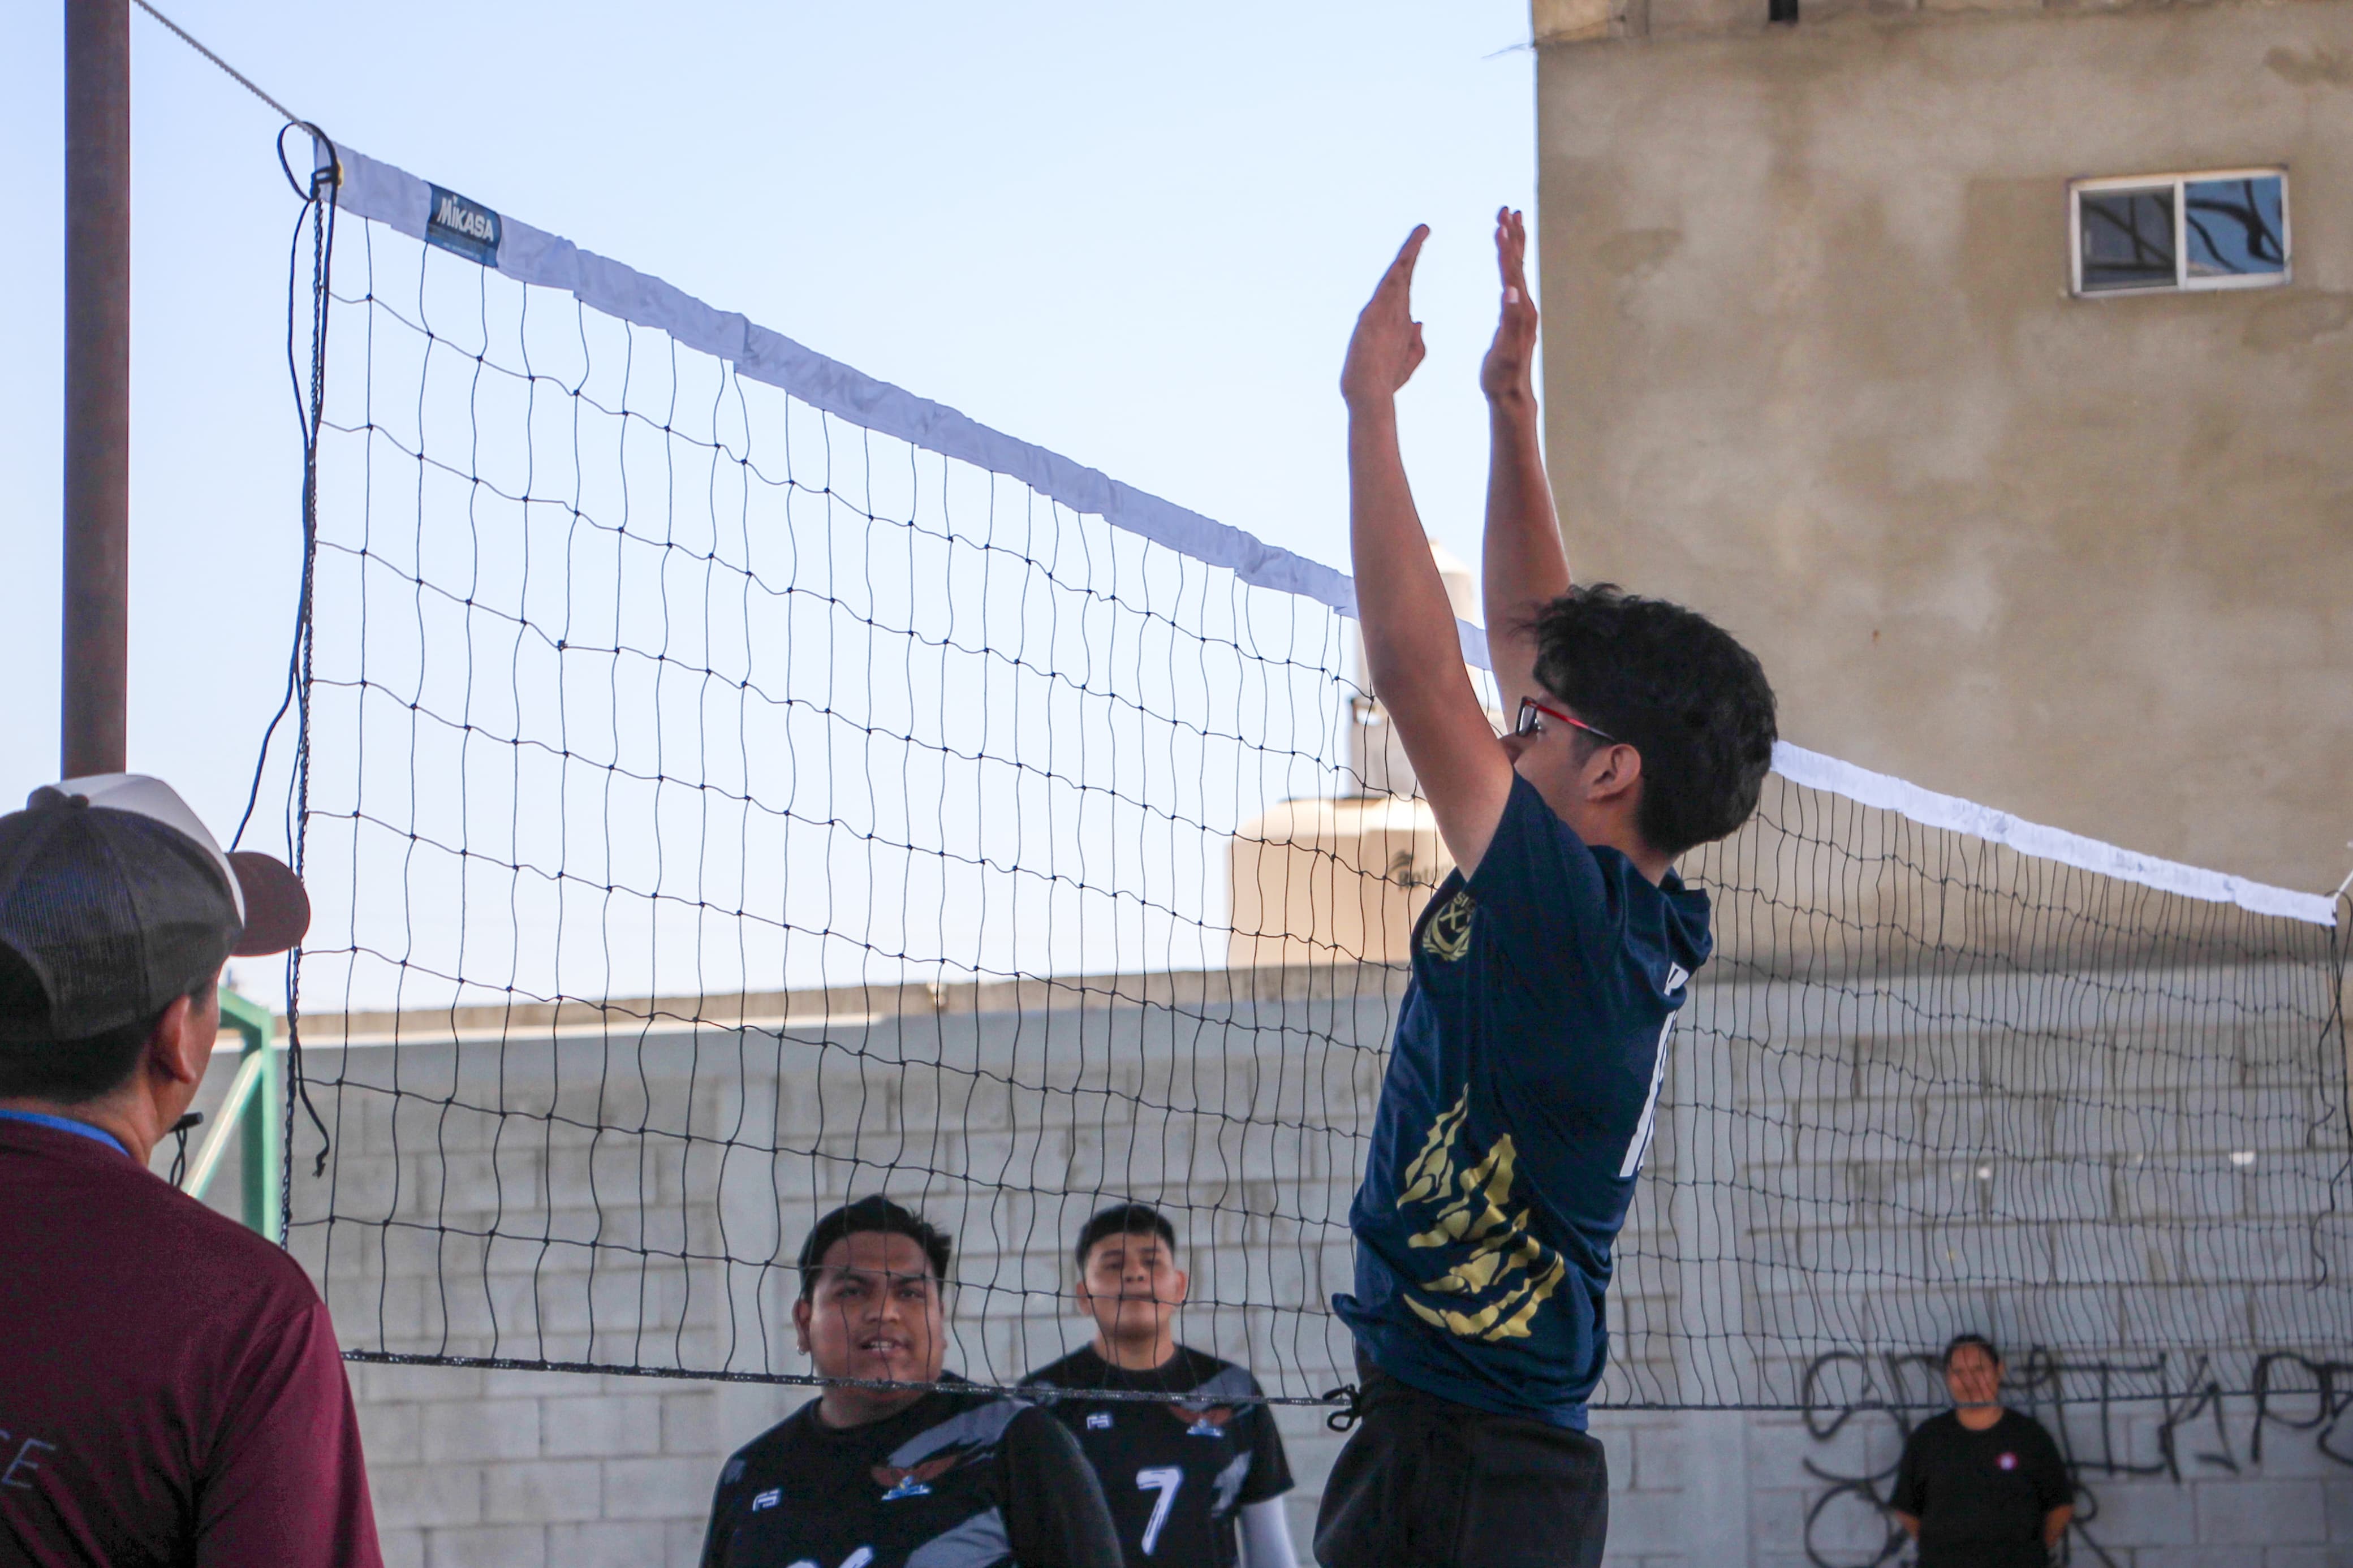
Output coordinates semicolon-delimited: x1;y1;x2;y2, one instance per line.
1398;1088;1570;1340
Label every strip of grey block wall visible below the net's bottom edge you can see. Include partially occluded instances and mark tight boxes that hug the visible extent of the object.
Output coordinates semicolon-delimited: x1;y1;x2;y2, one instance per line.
327;1366;2353;1568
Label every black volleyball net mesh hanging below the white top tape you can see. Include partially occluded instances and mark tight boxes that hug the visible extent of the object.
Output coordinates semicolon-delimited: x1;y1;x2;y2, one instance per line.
287;169;2348;1406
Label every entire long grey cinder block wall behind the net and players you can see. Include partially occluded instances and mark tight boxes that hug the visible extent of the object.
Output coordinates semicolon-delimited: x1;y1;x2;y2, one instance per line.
292;912;2353;1568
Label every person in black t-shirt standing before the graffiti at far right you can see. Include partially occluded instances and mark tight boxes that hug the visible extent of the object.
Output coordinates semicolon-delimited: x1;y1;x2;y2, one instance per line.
1889;1333;2075;1568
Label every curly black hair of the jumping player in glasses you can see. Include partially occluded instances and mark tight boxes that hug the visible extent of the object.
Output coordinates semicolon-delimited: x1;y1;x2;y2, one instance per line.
1527;583;1779;856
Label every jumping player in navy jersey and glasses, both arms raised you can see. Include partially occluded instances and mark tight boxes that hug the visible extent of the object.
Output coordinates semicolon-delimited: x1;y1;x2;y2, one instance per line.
1315;211;1774;1568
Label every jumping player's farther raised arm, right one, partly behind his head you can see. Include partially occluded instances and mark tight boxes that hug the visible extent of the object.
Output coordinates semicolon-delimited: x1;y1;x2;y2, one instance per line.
1477;207;1570;715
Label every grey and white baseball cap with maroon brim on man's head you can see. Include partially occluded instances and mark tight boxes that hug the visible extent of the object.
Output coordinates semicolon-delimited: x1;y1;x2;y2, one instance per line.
0;774;311;1042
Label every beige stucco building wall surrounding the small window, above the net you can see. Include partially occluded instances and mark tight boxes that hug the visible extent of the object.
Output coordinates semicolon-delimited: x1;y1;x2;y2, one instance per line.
1539;0;2353;891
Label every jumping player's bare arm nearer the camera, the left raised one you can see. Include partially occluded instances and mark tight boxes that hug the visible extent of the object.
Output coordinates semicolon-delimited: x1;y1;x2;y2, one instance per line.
1339;226;1541;875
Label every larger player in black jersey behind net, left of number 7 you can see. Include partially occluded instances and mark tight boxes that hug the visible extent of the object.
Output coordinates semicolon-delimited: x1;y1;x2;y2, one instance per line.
701;1196;1120;1568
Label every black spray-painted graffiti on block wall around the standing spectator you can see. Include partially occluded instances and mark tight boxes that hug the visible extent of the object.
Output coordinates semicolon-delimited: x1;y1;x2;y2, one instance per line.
1805;1347;2353;1568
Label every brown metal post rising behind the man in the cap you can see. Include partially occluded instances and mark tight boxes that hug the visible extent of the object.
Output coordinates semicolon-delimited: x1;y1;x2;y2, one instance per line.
59;0;132;778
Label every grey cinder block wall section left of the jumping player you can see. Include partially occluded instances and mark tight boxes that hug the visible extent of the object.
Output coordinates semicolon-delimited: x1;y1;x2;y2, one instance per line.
290;966;1395;1568
